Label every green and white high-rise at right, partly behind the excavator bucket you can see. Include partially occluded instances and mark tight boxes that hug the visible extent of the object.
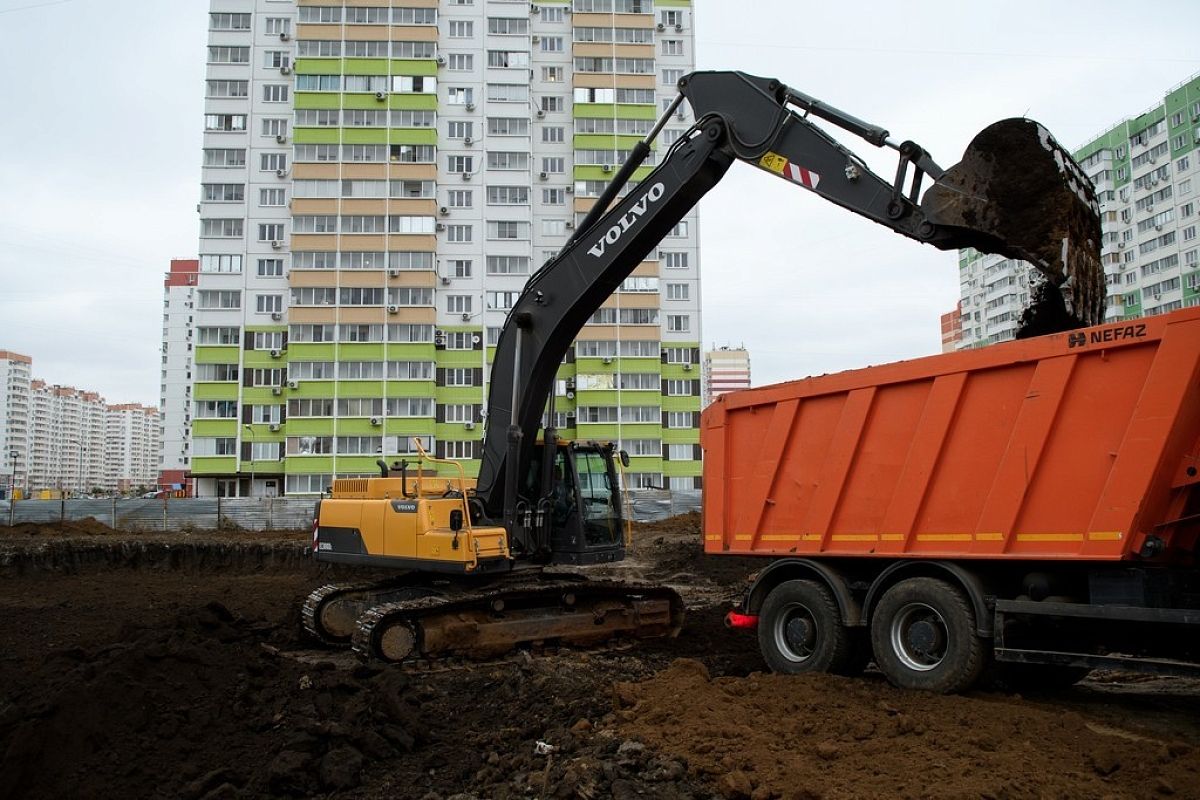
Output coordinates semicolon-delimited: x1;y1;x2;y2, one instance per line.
959;76;1200;348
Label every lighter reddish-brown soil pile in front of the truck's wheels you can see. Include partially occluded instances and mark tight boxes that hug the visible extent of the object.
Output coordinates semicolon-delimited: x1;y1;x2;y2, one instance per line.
616;660;1200;800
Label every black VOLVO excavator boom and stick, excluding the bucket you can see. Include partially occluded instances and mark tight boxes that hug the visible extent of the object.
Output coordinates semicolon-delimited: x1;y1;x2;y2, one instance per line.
475;72;1099;553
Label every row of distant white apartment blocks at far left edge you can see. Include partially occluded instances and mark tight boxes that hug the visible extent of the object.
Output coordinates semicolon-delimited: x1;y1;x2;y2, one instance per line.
0;350;160;497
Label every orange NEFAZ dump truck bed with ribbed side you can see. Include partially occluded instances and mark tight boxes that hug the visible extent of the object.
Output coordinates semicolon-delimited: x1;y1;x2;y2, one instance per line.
701;308;1200;560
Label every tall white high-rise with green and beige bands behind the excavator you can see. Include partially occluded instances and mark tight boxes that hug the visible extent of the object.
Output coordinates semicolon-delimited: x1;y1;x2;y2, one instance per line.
194;0;701;495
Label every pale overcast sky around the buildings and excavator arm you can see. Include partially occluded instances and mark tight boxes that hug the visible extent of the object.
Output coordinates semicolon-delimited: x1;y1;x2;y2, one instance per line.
0;0;1200;403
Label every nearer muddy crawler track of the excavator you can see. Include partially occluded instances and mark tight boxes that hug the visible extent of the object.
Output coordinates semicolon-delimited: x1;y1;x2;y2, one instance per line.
352;576;684;663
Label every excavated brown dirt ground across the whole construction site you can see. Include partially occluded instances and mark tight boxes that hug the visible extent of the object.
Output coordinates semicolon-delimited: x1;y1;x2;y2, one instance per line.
0;517;1200;800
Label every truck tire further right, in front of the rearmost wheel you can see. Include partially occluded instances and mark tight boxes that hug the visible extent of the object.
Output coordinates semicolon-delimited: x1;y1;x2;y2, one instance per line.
871;578;984;694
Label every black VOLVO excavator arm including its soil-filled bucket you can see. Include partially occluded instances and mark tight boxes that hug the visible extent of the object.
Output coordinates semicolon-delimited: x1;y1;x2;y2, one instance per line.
475;72;1103;553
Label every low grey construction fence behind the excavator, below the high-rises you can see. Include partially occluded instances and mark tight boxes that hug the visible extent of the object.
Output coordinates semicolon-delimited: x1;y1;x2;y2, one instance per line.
0;489;700;531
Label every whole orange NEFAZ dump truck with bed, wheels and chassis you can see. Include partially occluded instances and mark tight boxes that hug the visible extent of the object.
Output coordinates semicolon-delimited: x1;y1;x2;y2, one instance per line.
701;308;1200;692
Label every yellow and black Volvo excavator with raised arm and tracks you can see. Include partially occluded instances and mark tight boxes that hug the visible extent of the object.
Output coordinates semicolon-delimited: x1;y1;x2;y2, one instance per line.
301;72;1104;662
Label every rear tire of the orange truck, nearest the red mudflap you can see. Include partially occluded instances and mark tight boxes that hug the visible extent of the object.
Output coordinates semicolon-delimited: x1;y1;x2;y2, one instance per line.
758;581;853;675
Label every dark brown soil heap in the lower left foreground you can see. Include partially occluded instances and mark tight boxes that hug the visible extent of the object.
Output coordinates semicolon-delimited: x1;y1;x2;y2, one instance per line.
0;602;424;798
